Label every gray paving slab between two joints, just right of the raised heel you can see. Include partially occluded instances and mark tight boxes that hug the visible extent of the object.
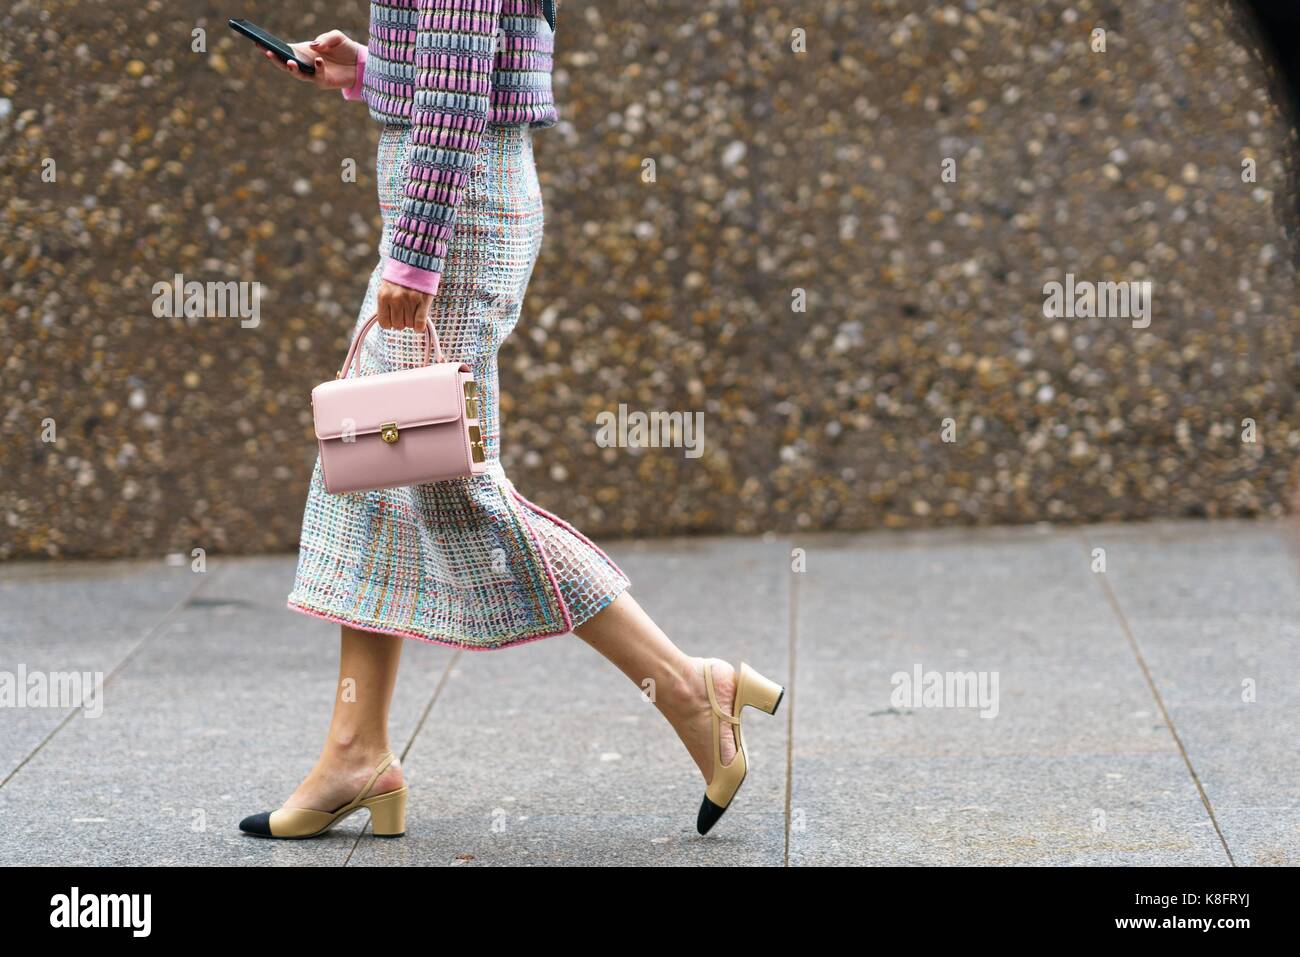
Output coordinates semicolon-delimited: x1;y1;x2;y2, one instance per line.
790;529;1225;865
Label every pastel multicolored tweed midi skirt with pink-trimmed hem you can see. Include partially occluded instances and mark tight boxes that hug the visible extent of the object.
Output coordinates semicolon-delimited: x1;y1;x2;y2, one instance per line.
289;126;629;649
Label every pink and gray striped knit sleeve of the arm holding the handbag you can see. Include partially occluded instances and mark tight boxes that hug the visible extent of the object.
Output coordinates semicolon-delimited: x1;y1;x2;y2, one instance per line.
384;0;502;293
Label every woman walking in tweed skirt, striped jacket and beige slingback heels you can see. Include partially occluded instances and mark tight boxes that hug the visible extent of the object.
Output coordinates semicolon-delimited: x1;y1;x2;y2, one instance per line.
239;0;784;837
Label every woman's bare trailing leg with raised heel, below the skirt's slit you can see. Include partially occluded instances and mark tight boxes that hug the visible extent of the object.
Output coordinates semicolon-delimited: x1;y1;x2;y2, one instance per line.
573;592;736;783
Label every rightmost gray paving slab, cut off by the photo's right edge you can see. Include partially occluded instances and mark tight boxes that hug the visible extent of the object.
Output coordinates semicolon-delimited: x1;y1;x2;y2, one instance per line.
1084;523;1300;866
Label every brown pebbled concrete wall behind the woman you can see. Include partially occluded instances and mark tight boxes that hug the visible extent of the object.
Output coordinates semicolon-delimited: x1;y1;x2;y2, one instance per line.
0;0;1300;558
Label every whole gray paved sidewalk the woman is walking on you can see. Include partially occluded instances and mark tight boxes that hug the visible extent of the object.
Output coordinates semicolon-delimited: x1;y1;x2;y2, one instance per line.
0;523;1300;866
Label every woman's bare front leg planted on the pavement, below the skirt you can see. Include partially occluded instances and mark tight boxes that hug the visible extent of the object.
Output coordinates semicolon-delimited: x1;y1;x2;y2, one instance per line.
285;625;406;811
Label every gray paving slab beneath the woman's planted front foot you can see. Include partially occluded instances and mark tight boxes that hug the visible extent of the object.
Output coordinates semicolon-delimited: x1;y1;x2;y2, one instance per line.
0;558;454;865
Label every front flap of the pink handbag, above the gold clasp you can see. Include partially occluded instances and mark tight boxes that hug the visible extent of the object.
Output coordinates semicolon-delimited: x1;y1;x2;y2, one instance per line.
312;363;469;438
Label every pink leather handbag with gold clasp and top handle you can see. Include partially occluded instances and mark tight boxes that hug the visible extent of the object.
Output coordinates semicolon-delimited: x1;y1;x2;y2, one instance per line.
312;315;486;492
